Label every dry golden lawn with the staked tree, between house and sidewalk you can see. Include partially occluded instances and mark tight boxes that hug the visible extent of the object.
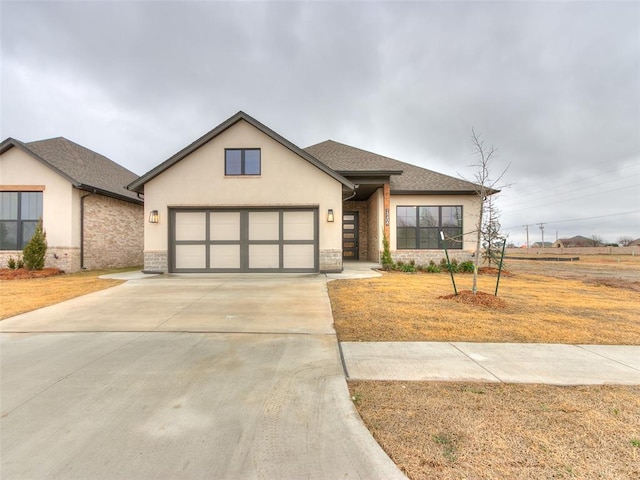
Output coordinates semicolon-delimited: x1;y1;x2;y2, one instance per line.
328;270;640;345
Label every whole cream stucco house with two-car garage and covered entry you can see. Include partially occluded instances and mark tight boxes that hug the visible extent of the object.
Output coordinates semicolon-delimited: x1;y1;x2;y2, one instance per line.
129;112;488;272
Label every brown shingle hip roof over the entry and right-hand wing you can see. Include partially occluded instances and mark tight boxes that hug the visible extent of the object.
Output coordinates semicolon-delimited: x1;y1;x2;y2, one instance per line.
304;140;484;195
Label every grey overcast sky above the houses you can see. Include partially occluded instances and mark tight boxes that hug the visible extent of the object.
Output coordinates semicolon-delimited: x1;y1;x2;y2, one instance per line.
0;0;640;244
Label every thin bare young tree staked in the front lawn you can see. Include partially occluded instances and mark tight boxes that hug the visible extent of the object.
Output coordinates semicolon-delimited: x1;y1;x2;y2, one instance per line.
470;128;509;294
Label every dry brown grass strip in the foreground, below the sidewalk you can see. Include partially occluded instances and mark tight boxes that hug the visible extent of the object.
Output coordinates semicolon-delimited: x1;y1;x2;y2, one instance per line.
349;381;640;480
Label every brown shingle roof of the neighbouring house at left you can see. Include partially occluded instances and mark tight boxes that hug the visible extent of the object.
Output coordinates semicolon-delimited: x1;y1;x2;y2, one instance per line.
0;137;143;204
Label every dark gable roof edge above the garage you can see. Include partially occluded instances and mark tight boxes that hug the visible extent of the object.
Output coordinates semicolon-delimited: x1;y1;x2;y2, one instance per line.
127;111;355;192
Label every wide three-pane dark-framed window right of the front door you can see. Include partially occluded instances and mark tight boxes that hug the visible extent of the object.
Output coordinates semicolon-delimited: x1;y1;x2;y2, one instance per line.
396;206;462;250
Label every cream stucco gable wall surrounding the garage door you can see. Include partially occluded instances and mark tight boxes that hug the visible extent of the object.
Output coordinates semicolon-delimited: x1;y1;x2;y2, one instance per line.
144;120;342;252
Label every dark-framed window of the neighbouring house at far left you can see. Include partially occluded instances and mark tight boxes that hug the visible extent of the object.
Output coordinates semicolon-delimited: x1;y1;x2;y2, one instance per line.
0;192;42;250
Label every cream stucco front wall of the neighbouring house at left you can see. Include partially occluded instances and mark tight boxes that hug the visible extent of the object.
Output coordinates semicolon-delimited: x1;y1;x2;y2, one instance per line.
0;148;80;248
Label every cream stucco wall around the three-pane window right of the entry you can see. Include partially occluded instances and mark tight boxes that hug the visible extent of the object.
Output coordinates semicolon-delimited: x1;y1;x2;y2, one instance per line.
389;195;480;251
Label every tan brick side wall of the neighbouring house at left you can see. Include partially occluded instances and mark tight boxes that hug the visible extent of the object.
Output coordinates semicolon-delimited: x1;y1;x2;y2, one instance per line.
83;195;144;270
